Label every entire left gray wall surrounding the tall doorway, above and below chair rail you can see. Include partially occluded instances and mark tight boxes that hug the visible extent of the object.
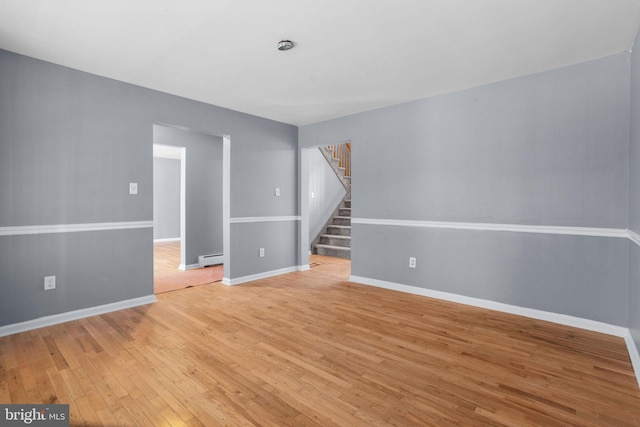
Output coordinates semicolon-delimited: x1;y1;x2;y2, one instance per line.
0;51;299;325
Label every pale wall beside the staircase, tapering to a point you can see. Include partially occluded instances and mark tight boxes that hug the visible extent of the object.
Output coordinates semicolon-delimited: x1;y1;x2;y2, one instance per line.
309;149;347;241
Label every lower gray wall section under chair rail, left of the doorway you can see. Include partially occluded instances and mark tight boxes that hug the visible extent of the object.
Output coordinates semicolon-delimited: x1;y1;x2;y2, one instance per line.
0;228;153;325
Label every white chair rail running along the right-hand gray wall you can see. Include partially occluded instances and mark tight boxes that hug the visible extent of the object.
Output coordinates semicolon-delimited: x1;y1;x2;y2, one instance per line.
351;218;640;241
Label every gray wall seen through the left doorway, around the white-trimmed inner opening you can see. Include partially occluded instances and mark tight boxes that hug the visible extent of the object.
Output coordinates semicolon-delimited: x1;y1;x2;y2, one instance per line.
153;125;222;265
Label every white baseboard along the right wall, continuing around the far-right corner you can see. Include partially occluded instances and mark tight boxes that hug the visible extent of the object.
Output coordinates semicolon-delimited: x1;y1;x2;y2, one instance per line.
349;276;640;387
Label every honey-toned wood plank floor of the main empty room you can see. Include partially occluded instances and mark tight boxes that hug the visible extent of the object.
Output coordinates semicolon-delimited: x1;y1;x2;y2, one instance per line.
0;257;640;426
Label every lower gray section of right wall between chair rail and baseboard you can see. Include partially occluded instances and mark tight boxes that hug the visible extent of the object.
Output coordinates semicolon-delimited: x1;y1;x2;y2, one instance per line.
351;224;627;325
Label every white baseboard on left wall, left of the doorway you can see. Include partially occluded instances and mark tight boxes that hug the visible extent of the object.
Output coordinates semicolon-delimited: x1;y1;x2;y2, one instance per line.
0;295;156;337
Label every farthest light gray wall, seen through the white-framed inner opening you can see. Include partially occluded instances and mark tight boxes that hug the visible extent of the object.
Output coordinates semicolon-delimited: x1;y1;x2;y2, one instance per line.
153;157;182;240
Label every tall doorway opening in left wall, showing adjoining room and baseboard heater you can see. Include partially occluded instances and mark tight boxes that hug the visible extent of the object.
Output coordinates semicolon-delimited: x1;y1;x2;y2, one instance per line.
153;125;230;294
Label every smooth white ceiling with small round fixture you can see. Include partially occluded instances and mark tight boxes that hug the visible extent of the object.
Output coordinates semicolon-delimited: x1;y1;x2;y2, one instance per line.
0;0;640;125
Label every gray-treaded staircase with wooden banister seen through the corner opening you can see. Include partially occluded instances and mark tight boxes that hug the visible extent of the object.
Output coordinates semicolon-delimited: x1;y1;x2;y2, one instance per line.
312;144;351;259
